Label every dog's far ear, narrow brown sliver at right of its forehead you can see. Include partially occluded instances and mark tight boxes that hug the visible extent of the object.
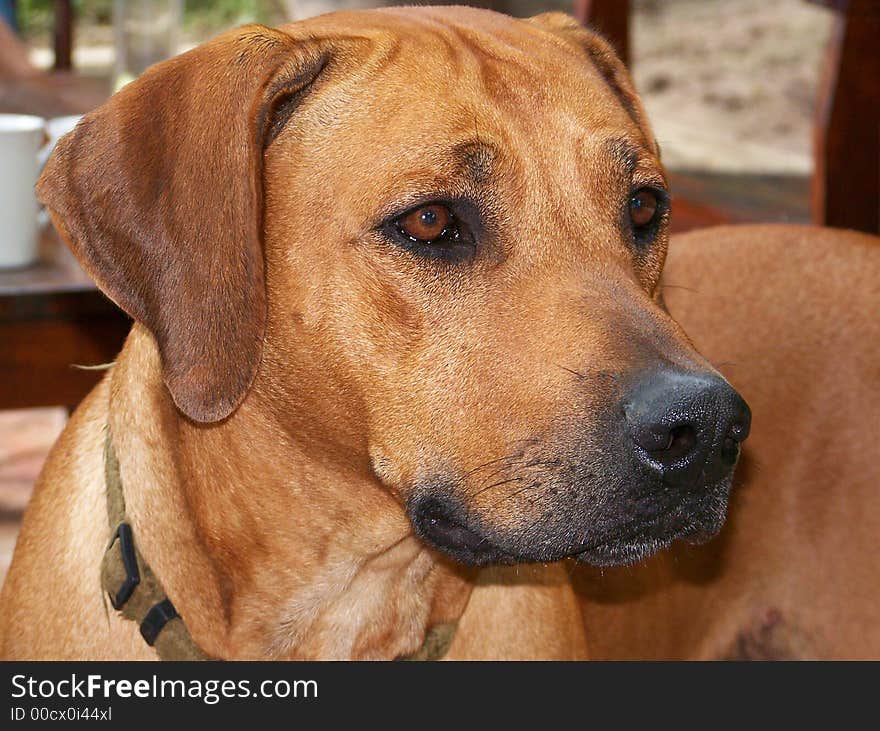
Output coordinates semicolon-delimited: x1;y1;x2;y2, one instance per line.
528;12;660;157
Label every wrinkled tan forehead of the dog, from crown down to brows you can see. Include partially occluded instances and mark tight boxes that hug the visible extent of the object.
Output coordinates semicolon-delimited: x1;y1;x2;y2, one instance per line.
274;8;650;229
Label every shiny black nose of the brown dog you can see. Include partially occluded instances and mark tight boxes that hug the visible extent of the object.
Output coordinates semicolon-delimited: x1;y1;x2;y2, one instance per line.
624;368;751;488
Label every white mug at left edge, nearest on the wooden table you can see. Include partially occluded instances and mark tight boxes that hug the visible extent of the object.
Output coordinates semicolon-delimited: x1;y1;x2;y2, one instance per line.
0;114;46;269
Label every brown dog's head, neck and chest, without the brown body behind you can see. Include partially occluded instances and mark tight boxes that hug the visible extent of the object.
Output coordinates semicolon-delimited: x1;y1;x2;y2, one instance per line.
0;8;868;658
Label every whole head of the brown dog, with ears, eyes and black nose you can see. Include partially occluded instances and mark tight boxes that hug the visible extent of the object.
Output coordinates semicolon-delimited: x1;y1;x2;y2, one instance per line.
39;8;749;564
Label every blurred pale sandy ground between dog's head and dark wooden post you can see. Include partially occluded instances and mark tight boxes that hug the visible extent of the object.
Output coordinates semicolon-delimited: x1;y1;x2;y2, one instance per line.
632;0;832;174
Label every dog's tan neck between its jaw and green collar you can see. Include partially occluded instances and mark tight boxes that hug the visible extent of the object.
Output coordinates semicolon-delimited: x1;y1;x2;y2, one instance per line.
109;325;470;659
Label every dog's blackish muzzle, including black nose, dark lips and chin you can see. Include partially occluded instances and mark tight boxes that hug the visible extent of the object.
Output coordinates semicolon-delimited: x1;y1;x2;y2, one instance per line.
407;367;751;565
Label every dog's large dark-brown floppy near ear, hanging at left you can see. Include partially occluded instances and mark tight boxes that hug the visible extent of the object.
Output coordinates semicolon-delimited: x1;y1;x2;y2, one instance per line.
37;26;328;422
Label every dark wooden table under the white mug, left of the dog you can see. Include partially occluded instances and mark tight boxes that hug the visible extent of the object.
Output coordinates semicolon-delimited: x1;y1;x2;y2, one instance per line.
0;226;131;409
